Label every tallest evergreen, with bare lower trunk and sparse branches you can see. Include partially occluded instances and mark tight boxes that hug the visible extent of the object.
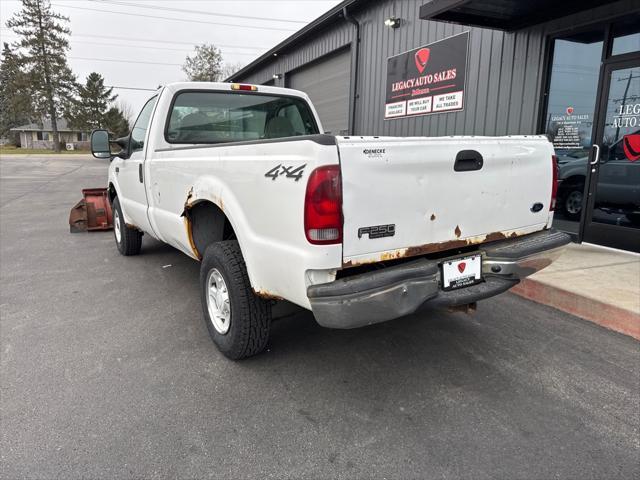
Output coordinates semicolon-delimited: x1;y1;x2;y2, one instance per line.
7;0;75;152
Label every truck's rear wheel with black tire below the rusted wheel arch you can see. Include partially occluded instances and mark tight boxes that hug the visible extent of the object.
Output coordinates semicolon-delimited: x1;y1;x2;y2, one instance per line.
200;240;271;360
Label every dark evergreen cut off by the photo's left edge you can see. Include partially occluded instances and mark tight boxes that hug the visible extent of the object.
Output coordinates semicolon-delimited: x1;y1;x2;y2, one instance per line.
0;43;34;142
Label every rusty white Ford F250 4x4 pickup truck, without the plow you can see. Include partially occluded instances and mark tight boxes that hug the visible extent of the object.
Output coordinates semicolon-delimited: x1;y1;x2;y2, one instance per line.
91;82;569;359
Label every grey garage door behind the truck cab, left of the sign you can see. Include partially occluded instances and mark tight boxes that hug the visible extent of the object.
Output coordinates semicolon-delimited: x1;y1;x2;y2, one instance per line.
286;50;351;135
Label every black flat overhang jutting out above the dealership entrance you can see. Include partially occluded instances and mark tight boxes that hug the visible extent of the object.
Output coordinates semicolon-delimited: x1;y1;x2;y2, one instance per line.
420;0;618;31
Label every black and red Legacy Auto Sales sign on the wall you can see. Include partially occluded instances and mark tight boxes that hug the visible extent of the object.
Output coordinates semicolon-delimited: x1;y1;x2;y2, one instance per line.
384;32;469;119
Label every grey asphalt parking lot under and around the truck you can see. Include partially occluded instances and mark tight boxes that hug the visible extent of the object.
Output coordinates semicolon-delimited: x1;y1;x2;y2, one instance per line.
0;156;640;479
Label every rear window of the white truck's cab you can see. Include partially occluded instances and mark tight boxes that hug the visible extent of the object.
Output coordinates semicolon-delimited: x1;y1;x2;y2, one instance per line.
165;91;319;144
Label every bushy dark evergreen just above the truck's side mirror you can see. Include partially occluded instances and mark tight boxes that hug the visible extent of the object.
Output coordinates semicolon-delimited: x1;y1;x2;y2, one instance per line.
67;72;117;130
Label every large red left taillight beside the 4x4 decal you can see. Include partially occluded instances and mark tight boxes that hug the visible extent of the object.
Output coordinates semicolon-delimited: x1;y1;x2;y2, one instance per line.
304;165;342;245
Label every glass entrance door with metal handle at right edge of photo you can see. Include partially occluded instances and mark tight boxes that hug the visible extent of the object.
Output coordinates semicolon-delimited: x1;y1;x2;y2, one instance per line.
583;58;640;251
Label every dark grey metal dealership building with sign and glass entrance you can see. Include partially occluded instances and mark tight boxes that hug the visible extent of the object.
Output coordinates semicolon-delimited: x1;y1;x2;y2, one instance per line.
228;0;640;251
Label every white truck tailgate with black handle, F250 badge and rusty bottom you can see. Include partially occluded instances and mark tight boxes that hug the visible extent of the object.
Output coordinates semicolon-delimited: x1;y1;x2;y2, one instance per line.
338;136;553;265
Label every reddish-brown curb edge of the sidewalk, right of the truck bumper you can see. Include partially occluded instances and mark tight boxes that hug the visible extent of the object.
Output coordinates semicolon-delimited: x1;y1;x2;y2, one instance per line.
511;278;640;340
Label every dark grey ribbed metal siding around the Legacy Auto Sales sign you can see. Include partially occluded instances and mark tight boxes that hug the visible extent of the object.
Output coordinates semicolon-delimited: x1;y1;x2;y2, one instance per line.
236;0;640;136
